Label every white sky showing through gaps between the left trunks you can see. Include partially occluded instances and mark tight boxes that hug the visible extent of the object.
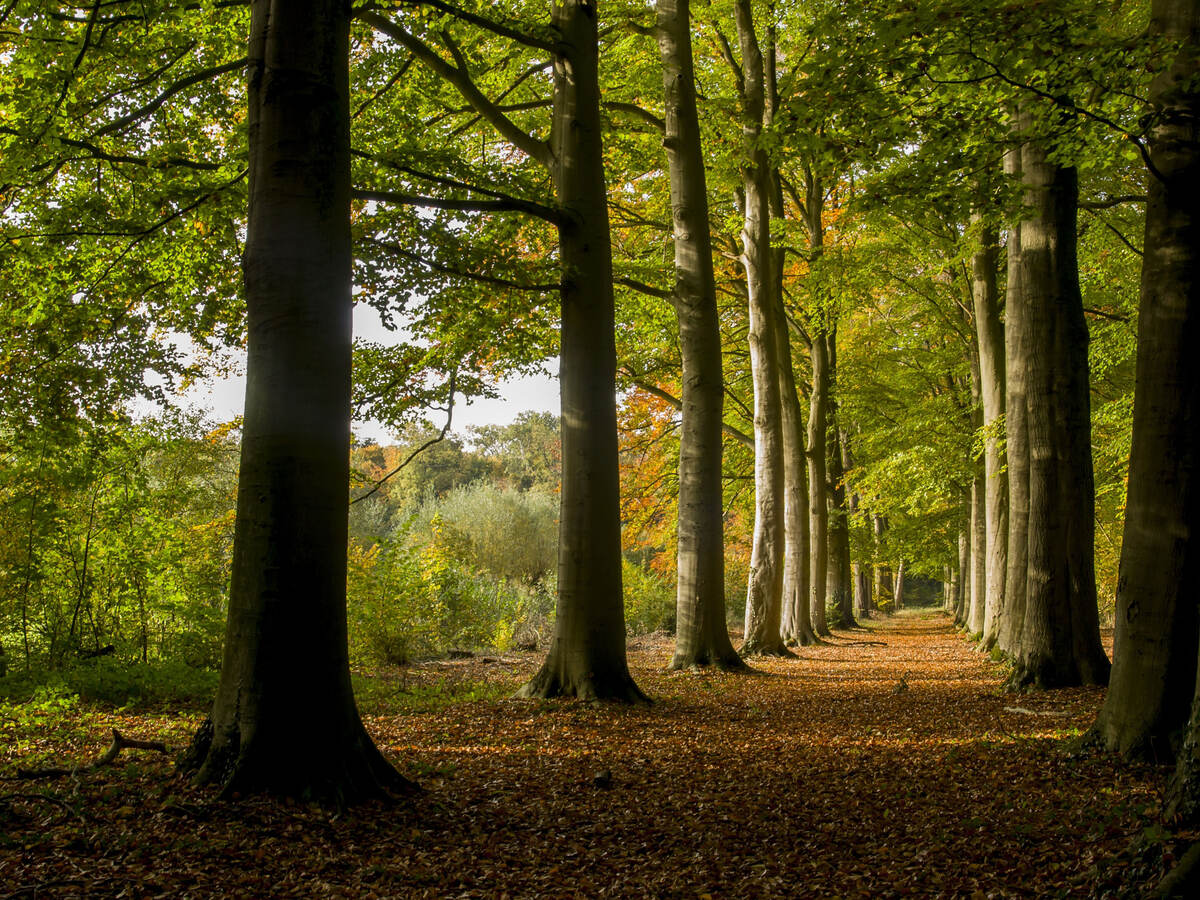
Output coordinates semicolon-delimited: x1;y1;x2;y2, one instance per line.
180;305;559;444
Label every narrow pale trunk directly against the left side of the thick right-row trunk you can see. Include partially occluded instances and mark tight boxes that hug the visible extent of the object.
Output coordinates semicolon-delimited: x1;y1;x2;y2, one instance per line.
996;145;1030;655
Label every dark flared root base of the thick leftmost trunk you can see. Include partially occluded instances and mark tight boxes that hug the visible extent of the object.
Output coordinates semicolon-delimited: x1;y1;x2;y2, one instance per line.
179;719;421;809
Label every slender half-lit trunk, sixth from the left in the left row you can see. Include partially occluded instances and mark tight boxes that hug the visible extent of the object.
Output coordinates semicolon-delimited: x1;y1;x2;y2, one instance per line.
809;334;830;637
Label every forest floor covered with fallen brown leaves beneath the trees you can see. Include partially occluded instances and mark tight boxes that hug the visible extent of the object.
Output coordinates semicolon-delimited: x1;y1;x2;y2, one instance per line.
0;612;1194;899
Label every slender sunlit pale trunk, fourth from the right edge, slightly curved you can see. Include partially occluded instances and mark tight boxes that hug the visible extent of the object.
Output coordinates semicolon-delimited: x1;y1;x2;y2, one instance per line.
971;214;1008;650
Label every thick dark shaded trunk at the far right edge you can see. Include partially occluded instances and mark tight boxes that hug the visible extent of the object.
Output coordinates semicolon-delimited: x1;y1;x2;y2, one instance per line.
1092;0;1200;763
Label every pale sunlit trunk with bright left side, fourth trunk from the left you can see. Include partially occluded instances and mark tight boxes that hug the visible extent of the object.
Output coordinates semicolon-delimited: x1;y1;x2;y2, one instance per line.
734;0;790;656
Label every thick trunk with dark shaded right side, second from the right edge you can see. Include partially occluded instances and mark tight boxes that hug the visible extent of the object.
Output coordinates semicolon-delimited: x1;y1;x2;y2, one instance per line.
1013;127;1109;688
